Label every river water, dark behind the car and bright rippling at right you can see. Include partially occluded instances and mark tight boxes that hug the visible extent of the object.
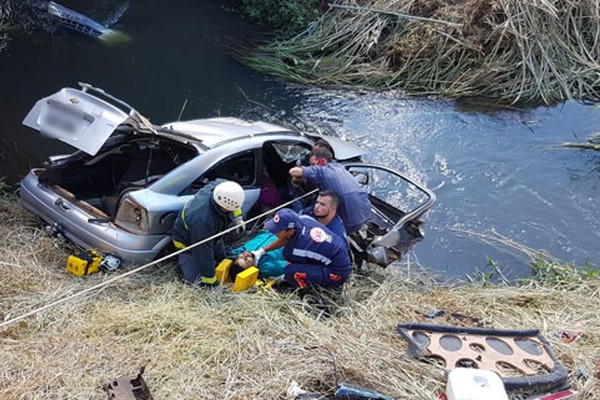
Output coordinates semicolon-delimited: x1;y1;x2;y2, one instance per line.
0;0;600;279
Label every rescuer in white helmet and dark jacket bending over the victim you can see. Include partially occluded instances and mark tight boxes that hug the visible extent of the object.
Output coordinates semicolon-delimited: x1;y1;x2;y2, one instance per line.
171;179;244;286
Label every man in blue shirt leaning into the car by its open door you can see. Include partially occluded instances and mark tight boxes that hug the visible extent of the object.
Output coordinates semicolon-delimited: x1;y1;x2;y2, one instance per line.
290;148;371;234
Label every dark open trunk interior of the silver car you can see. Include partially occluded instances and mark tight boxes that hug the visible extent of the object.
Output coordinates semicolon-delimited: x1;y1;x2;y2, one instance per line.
39;137;197;219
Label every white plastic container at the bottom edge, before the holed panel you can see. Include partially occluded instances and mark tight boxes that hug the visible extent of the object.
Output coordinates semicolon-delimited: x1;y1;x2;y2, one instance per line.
446;368;508;400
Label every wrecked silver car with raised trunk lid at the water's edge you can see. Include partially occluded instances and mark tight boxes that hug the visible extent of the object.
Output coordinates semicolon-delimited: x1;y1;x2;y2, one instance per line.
20;83;435;266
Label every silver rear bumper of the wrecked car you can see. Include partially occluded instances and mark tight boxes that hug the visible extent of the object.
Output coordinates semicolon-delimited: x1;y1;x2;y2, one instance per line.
19;171;171;264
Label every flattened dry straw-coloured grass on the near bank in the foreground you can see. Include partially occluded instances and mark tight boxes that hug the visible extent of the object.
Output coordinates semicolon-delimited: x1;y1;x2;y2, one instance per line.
0;193;600;400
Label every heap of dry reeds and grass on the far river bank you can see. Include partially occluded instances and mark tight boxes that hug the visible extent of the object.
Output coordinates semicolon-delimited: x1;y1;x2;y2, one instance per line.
239;0;600;104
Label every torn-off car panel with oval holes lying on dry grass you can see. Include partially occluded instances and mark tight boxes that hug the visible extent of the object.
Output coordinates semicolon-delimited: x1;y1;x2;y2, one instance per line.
397;323;568;394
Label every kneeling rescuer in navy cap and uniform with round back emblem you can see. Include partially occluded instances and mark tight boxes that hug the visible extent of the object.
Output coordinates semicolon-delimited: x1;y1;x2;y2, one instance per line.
251;208;352;288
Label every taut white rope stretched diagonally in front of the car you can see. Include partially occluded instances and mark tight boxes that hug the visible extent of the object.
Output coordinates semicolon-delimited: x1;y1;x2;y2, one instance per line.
0;189;319;329
